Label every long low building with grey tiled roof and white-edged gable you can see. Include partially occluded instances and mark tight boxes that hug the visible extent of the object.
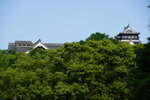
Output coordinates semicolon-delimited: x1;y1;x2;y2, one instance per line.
8;39;64;53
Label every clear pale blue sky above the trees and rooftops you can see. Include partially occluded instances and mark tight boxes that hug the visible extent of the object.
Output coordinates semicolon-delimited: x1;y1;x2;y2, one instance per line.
0;0;150;49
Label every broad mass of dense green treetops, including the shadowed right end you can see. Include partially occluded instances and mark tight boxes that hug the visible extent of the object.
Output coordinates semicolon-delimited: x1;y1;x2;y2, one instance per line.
0;32;150;100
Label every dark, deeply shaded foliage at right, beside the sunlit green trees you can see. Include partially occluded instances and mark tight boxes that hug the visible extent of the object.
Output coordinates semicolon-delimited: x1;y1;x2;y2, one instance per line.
130;43;150;100
